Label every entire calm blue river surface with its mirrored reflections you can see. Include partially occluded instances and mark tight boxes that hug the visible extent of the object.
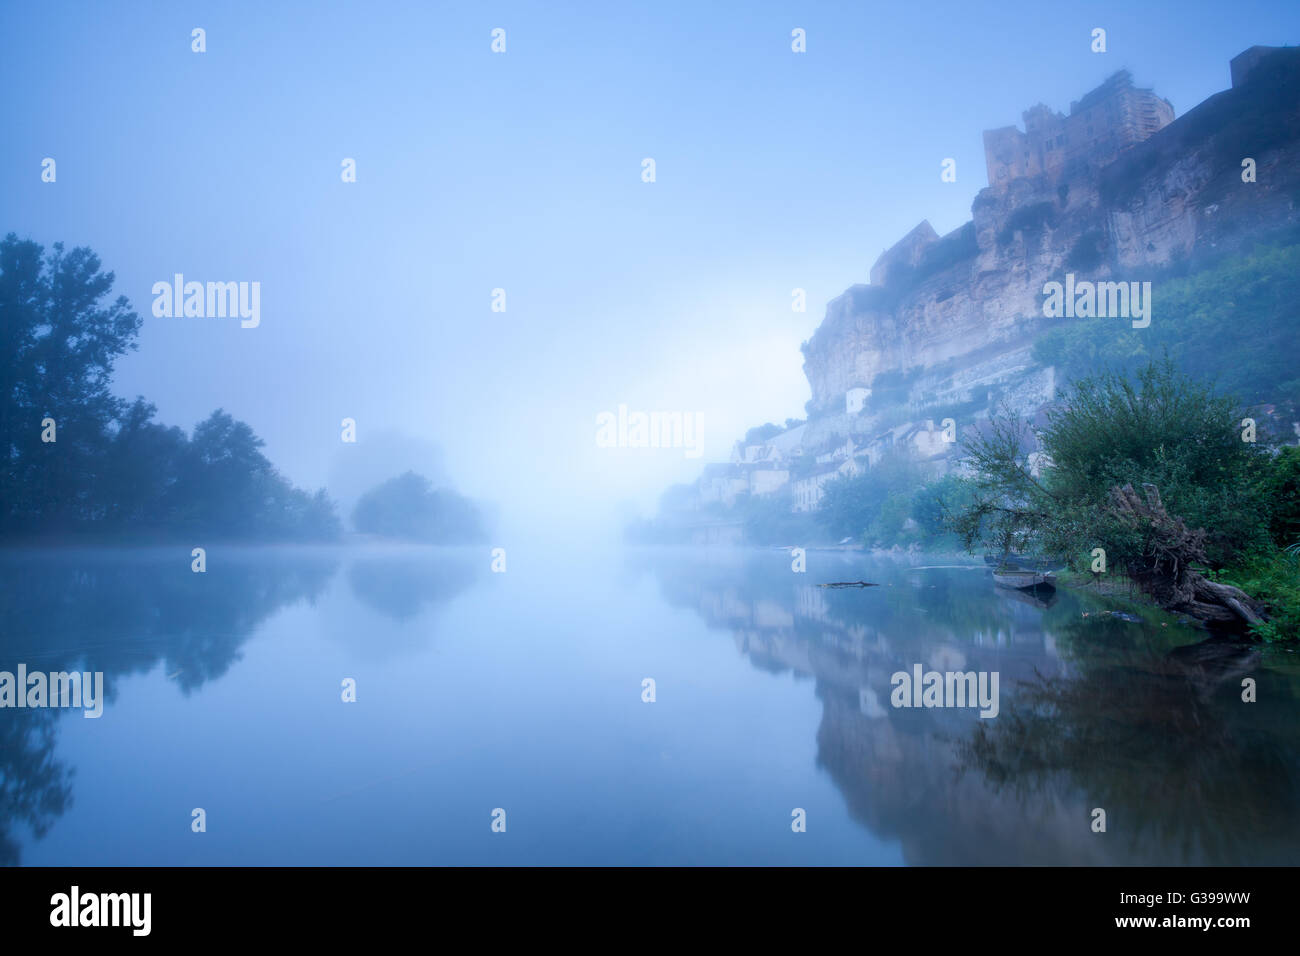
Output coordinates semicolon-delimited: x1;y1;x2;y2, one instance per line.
0;548;1300;865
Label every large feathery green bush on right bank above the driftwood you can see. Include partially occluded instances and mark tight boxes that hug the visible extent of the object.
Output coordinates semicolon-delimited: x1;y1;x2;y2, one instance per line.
957;359;1271;568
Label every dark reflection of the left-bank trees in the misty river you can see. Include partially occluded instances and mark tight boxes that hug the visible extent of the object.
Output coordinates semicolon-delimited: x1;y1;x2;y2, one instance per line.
0;548;496;865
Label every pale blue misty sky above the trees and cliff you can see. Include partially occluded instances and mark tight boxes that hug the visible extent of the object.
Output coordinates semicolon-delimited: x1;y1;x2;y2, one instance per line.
0;0;1300;522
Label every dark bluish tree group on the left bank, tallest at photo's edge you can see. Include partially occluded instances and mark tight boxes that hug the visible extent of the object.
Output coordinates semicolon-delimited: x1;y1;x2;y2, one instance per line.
0;234;338;538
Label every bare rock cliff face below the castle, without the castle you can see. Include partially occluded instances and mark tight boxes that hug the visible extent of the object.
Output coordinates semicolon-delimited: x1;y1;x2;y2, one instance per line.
803;48;1300;432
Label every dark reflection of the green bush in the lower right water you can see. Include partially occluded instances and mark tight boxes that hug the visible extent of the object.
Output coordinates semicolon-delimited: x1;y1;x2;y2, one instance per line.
959;640;1300;865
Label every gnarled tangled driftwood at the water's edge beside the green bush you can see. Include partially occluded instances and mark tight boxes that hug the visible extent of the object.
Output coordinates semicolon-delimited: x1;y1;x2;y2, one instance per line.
1110;484;1265;624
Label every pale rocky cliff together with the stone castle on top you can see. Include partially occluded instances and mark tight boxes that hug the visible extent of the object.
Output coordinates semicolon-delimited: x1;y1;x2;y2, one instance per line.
677;46;1300;544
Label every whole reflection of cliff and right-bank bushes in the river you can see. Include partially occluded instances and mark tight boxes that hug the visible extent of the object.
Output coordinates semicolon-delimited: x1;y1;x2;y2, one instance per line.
634;551;1300;865
